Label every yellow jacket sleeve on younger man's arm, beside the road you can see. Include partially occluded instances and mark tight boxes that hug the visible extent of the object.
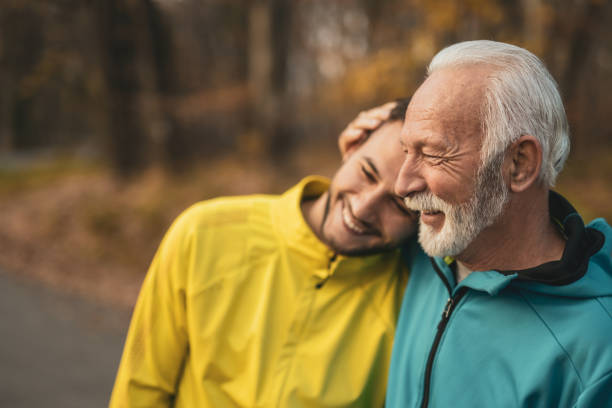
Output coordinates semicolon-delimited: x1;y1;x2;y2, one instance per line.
110;212;189;408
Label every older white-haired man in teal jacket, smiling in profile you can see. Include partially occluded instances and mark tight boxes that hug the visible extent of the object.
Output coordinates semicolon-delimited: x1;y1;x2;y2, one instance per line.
387;41;612;408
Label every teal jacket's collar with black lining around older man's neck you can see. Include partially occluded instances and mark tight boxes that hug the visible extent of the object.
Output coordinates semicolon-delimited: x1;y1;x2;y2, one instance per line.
432;191;604;295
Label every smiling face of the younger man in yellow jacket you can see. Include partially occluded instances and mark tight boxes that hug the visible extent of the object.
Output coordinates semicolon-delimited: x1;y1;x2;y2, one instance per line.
317;120;417;255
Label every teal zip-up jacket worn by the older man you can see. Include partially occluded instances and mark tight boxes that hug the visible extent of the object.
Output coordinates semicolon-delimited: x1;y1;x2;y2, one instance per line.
386;193;612;408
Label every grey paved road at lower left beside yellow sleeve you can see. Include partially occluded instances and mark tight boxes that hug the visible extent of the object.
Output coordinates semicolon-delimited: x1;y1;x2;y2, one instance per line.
0;271;129;408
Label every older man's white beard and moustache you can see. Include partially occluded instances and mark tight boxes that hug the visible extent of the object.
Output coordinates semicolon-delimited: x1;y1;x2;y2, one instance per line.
404;154;509;257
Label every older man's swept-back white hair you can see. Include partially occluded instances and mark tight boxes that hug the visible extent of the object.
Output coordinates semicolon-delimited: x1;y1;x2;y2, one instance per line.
427;40;570;188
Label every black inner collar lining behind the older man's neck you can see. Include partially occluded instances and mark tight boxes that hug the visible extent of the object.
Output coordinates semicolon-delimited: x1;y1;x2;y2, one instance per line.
499;191;605;286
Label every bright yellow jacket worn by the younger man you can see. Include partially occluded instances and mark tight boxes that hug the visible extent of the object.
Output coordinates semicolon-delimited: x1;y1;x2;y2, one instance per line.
110;177;407;408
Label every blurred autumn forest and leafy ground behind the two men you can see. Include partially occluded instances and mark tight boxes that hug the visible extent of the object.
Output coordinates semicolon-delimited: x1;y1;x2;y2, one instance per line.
0;0;612;307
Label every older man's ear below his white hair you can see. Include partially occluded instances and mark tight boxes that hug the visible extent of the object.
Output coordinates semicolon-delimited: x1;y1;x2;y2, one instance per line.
506;135;542;193
